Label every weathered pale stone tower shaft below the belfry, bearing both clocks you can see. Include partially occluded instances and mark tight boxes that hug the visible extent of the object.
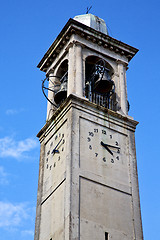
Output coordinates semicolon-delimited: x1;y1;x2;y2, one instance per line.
35;95;143;240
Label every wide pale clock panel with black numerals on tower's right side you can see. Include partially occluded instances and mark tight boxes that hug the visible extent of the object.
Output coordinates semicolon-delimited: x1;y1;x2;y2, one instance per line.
80;118;129;183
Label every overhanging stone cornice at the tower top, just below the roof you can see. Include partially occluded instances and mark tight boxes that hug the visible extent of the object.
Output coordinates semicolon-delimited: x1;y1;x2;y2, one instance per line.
37;19;138;72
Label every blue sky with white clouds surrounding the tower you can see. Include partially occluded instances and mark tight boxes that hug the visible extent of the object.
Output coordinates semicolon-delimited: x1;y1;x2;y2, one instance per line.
0;0;160;240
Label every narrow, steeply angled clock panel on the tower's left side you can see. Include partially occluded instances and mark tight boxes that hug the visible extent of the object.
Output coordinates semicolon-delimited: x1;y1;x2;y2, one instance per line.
43;124;66;195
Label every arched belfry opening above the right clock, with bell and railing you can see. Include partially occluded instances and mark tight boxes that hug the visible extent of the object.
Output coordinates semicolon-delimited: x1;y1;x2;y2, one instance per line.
85;56;115;110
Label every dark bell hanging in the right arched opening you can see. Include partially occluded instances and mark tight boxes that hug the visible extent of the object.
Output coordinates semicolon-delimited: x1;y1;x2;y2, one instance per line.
94;71;114;94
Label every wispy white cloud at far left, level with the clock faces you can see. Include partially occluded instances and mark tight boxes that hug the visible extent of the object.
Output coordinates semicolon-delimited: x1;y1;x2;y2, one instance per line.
0;137;38;159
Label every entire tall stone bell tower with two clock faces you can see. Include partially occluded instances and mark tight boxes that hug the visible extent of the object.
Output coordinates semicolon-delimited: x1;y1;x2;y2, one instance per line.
34;14;143;240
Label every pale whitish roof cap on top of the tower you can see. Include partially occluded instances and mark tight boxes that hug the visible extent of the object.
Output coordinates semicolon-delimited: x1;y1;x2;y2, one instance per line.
73;13;108;35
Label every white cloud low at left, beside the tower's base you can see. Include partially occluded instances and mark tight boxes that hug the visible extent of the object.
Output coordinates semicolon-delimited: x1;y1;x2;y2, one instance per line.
0;202;30;228
